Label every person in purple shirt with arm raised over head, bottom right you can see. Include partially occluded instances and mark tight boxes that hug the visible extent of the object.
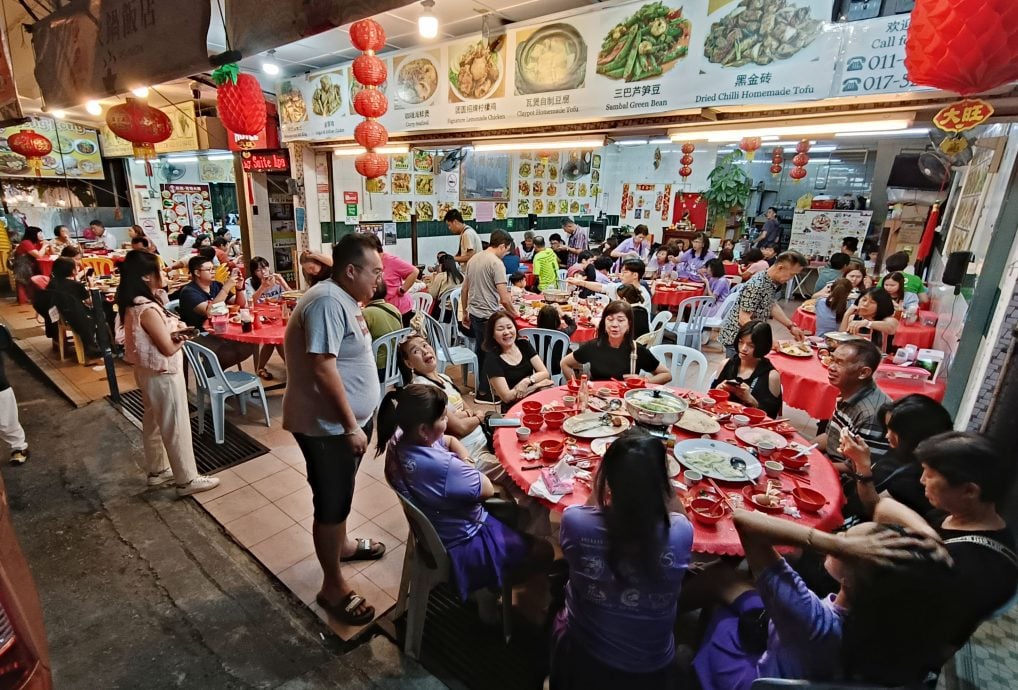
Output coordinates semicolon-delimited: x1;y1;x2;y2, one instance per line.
687;511;952;690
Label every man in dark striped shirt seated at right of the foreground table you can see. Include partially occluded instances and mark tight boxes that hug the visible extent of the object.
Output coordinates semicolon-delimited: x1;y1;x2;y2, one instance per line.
816;340;891;480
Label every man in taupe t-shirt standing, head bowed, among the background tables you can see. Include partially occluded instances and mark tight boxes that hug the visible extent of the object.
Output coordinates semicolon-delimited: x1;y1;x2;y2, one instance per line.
460;230;519;402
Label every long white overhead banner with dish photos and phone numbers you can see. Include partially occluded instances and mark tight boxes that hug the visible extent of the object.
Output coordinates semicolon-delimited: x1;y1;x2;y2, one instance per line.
277;0;932;141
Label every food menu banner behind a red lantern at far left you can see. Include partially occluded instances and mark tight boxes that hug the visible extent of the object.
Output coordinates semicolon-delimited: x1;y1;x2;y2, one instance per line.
0;117;105;180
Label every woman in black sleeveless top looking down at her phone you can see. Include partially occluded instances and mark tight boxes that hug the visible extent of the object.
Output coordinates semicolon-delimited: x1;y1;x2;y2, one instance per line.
711;321;781;418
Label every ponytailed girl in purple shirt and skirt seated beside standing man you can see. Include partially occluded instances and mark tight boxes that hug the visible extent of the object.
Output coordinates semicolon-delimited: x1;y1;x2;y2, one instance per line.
376;384;551;599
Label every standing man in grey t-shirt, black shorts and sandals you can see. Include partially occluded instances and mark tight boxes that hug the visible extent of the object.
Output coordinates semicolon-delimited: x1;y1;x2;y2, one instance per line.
283;233;385;625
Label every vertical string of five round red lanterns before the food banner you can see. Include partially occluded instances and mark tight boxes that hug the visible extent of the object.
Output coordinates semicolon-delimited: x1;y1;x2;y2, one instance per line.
350;19;389;179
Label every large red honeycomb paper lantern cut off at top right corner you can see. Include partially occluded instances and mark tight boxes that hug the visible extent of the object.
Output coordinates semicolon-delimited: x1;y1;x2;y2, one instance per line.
905;0;1018;96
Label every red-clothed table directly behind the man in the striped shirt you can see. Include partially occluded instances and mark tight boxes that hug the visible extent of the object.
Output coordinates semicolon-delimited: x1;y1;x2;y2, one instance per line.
769;352;947;419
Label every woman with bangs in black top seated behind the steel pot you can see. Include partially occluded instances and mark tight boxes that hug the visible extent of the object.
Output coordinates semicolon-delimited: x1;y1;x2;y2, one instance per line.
562;300;672;384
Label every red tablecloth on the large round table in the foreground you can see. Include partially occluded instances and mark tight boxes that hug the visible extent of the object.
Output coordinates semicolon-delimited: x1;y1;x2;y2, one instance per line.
495;383;845;556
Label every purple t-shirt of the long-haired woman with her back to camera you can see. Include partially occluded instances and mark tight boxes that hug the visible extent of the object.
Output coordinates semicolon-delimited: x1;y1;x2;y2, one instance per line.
559;506;693;673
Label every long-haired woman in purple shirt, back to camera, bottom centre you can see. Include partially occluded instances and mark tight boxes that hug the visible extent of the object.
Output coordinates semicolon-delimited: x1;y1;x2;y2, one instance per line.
551;432;693;690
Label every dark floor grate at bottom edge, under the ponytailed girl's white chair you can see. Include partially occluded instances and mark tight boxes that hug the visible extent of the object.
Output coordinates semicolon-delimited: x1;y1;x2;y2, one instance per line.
404;584;550;690
